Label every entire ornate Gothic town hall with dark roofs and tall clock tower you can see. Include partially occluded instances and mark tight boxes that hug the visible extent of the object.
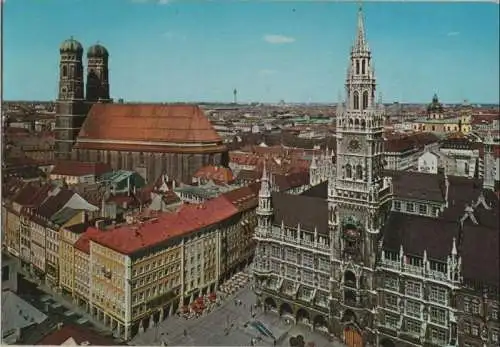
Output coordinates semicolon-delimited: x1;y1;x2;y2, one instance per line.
254;5;499;346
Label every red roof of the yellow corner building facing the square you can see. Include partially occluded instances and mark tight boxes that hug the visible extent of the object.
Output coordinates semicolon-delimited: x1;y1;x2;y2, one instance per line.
89;197;238;254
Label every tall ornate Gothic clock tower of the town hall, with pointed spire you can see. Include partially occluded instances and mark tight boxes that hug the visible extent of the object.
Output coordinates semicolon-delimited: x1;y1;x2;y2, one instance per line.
328;6;392;345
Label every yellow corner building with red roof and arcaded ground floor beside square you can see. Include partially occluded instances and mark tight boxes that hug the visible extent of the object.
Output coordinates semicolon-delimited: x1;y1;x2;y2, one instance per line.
80;197;238;339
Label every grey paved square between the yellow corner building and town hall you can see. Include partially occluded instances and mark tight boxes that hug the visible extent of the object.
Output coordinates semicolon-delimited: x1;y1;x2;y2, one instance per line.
130;286;344;347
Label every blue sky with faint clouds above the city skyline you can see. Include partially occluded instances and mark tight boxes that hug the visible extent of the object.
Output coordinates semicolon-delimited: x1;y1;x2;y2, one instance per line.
3;0;500;102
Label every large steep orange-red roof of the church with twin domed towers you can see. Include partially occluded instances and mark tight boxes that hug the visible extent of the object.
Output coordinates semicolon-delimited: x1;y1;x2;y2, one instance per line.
77;104;221;143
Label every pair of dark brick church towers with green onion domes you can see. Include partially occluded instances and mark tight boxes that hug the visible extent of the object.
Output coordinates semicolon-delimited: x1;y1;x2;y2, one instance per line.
55;38;111;159
